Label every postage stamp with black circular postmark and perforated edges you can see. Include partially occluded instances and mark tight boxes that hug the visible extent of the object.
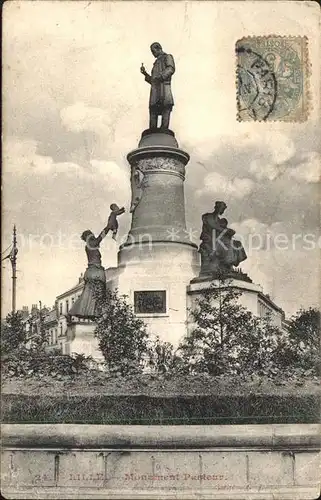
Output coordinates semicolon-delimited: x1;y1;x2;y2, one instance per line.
236;35;309;122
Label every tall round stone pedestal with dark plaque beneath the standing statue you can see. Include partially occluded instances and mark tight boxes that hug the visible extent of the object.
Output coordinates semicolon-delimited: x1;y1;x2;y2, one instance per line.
114;130;199;345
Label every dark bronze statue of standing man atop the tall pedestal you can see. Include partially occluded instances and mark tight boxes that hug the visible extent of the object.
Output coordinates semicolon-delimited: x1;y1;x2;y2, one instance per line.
140;42;175;129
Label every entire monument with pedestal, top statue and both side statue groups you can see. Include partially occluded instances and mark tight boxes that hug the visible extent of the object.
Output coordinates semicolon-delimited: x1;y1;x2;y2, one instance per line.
64;42;280;358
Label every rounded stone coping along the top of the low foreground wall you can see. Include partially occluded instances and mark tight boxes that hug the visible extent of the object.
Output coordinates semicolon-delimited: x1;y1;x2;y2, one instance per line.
2;424;321;450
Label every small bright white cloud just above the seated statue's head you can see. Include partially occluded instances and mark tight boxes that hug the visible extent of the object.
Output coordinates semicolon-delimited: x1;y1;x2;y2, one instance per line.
196;172;254;198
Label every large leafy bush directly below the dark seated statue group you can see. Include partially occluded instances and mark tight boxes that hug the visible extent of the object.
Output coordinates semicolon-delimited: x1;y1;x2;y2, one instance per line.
179;279;275;376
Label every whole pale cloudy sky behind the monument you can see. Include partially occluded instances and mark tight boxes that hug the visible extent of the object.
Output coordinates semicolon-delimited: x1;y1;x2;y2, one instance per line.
2;1;321;314
